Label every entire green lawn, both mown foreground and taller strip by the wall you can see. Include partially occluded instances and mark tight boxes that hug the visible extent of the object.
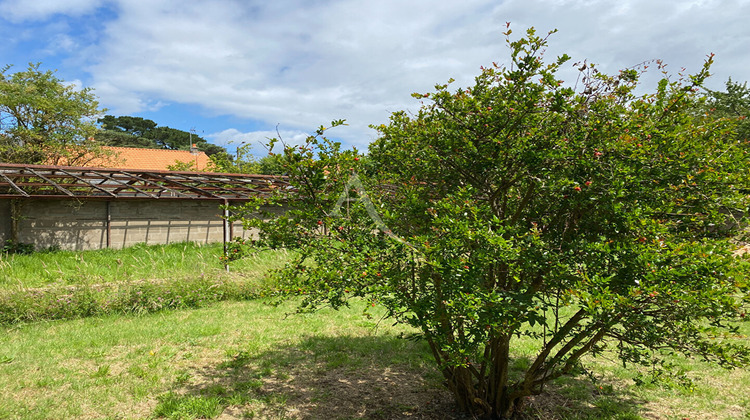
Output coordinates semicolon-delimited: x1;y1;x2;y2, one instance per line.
0;244;750;419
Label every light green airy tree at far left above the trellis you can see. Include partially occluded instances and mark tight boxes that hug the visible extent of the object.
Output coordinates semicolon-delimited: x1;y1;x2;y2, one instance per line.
0;64;102;165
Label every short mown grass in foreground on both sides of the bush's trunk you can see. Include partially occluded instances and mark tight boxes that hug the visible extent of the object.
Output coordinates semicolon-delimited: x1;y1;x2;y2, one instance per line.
0;300;750;419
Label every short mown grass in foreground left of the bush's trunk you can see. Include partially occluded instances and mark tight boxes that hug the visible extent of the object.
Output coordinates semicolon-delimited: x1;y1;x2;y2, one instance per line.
0;301;450;419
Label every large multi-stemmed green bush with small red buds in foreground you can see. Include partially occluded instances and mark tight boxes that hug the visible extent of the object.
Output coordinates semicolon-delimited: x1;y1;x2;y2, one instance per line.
236;29;750;418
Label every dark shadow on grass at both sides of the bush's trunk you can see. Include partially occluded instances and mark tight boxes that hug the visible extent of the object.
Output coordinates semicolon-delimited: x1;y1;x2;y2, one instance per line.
154;336;652;420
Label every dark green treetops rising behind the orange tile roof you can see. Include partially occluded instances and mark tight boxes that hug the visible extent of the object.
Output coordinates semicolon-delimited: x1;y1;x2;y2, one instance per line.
96;115;226;156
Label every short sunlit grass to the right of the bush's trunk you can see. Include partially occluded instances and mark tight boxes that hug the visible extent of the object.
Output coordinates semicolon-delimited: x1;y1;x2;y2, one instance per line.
513;322;750;420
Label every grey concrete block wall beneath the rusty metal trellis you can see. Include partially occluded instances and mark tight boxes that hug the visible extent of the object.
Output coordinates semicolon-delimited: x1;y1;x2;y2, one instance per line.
0;199;270;250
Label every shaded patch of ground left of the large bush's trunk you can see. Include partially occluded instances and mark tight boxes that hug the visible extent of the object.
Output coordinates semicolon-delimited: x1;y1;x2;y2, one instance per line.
175;337;469;420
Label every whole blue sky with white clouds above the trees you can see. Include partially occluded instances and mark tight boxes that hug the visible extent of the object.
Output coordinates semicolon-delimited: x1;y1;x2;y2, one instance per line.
0;0;750;156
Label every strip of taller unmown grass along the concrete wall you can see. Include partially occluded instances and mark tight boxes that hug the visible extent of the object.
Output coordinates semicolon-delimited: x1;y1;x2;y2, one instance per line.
0;243;286;324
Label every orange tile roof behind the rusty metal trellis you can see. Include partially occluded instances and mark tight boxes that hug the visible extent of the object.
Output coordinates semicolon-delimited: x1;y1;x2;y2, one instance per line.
92;146;210;171
